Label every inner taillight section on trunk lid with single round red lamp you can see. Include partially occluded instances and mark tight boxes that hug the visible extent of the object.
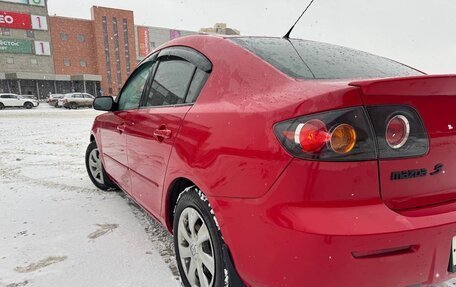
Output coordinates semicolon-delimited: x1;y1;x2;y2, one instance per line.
367;105;429;159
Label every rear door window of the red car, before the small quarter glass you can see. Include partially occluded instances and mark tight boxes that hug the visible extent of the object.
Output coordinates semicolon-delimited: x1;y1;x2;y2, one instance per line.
146;59;195;107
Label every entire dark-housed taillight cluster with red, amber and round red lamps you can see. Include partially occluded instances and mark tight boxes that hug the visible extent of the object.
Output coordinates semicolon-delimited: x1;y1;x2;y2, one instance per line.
274;105;429;161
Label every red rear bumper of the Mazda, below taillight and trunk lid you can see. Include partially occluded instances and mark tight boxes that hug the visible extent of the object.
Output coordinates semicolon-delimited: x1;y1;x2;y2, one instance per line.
209;160;456;287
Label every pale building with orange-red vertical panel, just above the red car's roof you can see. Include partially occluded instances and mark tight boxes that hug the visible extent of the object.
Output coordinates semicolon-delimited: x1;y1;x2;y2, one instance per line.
136;26;198;60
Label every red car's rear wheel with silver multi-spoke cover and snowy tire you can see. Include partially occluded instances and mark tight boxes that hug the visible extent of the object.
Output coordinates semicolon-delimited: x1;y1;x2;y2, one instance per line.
173;186;228;287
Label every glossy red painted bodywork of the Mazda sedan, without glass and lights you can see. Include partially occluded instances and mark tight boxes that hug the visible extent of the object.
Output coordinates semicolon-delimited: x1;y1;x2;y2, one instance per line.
92;36;456;287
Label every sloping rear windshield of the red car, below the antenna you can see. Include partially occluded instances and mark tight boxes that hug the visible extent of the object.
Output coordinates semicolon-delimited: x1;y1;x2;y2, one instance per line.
230;38;422;79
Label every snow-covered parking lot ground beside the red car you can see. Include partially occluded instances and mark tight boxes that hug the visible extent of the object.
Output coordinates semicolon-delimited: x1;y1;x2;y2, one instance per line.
0;104;456;287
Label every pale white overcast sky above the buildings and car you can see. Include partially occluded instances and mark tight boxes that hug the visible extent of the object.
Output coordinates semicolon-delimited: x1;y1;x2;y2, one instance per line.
48;0;456;73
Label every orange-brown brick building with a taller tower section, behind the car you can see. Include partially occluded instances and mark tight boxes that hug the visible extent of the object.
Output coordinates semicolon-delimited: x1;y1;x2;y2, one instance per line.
49;7;137;95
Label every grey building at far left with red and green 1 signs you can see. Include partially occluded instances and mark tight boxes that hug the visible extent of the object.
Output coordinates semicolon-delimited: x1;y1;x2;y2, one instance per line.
0;0;101;99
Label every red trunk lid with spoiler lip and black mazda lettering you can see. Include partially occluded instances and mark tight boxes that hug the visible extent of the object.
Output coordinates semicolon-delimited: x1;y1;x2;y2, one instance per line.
350;75;456;213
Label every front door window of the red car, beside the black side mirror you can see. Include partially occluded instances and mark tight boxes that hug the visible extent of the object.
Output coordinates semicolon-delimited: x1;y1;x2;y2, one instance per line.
119;62;153;110
